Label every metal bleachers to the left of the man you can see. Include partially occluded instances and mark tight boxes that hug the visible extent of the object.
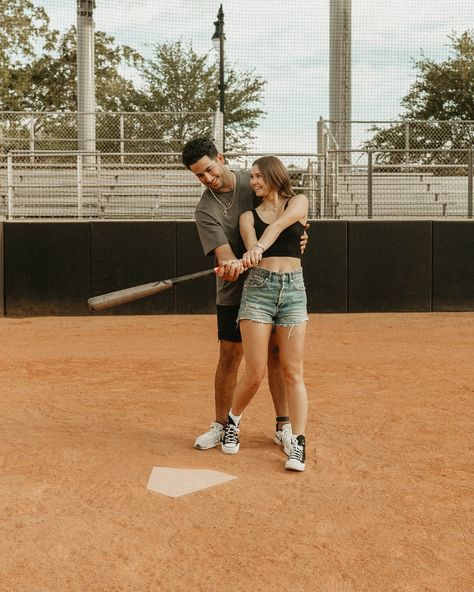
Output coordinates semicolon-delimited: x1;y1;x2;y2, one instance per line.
0;167;202;219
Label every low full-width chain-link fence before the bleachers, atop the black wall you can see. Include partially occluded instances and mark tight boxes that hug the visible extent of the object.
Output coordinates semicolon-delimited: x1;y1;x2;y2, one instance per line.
0;150;474;220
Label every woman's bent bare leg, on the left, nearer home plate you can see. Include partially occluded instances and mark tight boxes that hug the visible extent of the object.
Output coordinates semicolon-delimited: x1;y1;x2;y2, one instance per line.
232;320;272;415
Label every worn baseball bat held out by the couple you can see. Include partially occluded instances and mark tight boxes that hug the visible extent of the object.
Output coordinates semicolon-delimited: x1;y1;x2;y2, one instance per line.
87;267;219;311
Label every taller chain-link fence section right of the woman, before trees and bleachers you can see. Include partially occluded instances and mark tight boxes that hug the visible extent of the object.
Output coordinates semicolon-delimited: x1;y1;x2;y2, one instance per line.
318;119;474;218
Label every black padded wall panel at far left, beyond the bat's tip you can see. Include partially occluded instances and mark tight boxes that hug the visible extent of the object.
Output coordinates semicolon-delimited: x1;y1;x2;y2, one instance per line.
3;222;90;316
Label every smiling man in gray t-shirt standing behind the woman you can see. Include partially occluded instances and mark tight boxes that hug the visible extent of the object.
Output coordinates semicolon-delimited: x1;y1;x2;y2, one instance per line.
182;138;307;454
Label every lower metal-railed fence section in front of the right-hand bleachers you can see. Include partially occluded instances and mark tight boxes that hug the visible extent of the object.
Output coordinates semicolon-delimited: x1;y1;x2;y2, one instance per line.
322;149;473;219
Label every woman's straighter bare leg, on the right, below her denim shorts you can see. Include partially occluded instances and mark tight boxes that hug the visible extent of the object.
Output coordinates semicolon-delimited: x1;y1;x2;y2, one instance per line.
276;322;308;434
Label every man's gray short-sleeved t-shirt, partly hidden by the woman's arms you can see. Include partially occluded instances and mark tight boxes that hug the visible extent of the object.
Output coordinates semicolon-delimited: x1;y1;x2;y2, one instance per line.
195;171;256;305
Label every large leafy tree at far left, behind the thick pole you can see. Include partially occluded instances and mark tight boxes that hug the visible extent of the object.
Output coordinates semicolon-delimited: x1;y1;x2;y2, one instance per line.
0;9;146;151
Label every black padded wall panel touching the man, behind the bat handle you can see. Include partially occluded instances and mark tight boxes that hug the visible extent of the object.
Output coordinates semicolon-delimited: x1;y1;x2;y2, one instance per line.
175;221;216;314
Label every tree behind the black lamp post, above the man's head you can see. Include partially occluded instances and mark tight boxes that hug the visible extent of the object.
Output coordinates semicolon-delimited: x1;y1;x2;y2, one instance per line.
141;41;266;151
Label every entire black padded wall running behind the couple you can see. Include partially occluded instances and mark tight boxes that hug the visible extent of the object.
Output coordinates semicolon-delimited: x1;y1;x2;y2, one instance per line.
0;220;474;316
